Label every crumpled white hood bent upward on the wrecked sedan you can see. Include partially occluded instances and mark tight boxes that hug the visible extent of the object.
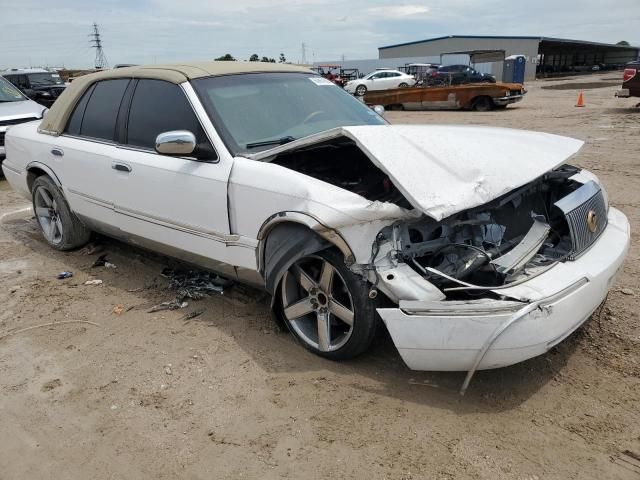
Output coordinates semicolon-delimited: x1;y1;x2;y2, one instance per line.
251;125;584;220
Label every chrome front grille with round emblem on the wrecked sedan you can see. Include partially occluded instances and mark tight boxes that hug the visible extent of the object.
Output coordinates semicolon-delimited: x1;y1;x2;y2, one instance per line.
556;181;608;260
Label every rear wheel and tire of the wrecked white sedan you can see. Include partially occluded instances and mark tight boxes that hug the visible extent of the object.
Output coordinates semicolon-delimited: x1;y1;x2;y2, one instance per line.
31;175;91;251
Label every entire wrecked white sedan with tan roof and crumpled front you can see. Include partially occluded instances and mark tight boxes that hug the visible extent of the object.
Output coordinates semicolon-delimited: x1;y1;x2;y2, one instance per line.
3;62;630;390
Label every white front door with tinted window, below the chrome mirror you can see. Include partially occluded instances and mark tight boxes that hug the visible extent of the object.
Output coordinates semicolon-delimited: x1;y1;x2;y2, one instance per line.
105;79;235;275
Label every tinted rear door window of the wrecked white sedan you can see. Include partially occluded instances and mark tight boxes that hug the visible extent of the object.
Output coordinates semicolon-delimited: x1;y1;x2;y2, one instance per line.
79;79;129;141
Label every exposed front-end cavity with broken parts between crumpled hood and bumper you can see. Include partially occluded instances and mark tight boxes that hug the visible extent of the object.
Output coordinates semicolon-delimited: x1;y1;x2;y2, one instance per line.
374;165;583;298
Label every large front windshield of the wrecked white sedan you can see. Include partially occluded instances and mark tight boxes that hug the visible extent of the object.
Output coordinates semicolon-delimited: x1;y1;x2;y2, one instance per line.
191;73;386;155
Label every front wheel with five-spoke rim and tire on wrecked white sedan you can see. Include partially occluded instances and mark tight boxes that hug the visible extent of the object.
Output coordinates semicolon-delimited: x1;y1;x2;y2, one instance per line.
276;249;378;360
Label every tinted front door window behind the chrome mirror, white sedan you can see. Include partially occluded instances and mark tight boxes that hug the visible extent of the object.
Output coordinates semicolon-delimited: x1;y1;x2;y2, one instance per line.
126;80;215;158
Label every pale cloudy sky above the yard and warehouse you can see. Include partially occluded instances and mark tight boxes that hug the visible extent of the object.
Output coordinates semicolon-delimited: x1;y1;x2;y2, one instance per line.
0;0;640;70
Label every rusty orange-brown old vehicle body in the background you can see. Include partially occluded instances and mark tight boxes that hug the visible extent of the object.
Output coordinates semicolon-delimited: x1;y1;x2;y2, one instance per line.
364;83;527;112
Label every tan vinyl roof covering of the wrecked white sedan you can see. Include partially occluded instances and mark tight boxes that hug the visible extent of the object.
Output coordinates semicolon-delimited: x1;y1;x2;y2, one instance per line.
39;62;314;135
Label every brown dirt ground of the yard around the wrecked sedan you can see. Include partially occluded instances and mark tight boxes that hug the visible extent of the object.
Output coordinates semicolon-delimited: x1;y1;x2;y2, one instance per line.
0;74;640;480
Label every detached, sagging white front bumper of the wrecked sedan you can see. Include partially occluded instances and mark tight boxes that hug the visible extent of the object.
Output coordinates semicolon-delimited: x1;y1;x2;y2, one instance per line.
378;208;631;372
